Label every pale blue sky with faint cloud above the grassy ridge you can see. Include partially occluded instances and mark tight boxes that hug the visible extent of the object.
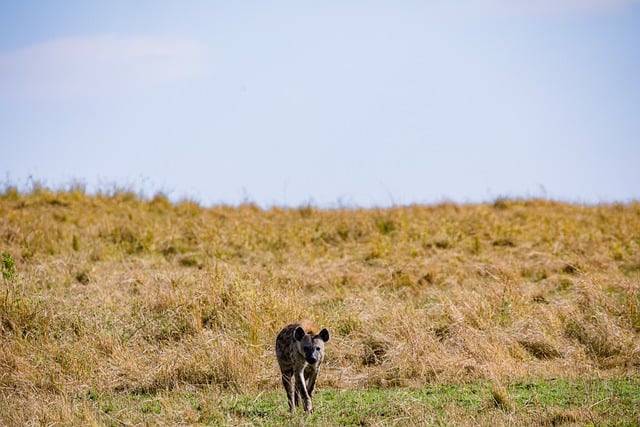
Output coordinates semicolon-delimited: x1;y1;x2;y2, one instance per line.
0;0;640;207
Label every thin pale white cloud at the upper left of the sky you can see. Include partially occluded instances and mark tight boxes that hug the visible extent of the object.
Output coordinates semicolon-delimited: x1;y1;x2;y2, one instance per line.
0;35;208;99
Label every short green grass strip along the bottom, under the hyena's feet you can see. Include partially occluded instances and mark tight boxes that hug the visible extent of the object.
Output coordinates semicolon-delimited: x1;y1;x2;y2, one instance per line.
78;376;640;426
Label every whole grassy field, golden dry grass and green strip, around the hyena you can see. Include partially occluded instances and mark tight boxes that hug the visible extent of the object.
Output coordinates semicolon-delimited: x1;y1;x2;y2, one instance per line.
0;186;640;426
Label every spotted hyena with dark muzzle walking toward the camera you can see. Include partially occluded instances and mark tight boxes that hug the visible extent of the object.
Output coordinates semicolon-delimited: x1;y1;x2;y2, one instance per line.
276;319;329;413
